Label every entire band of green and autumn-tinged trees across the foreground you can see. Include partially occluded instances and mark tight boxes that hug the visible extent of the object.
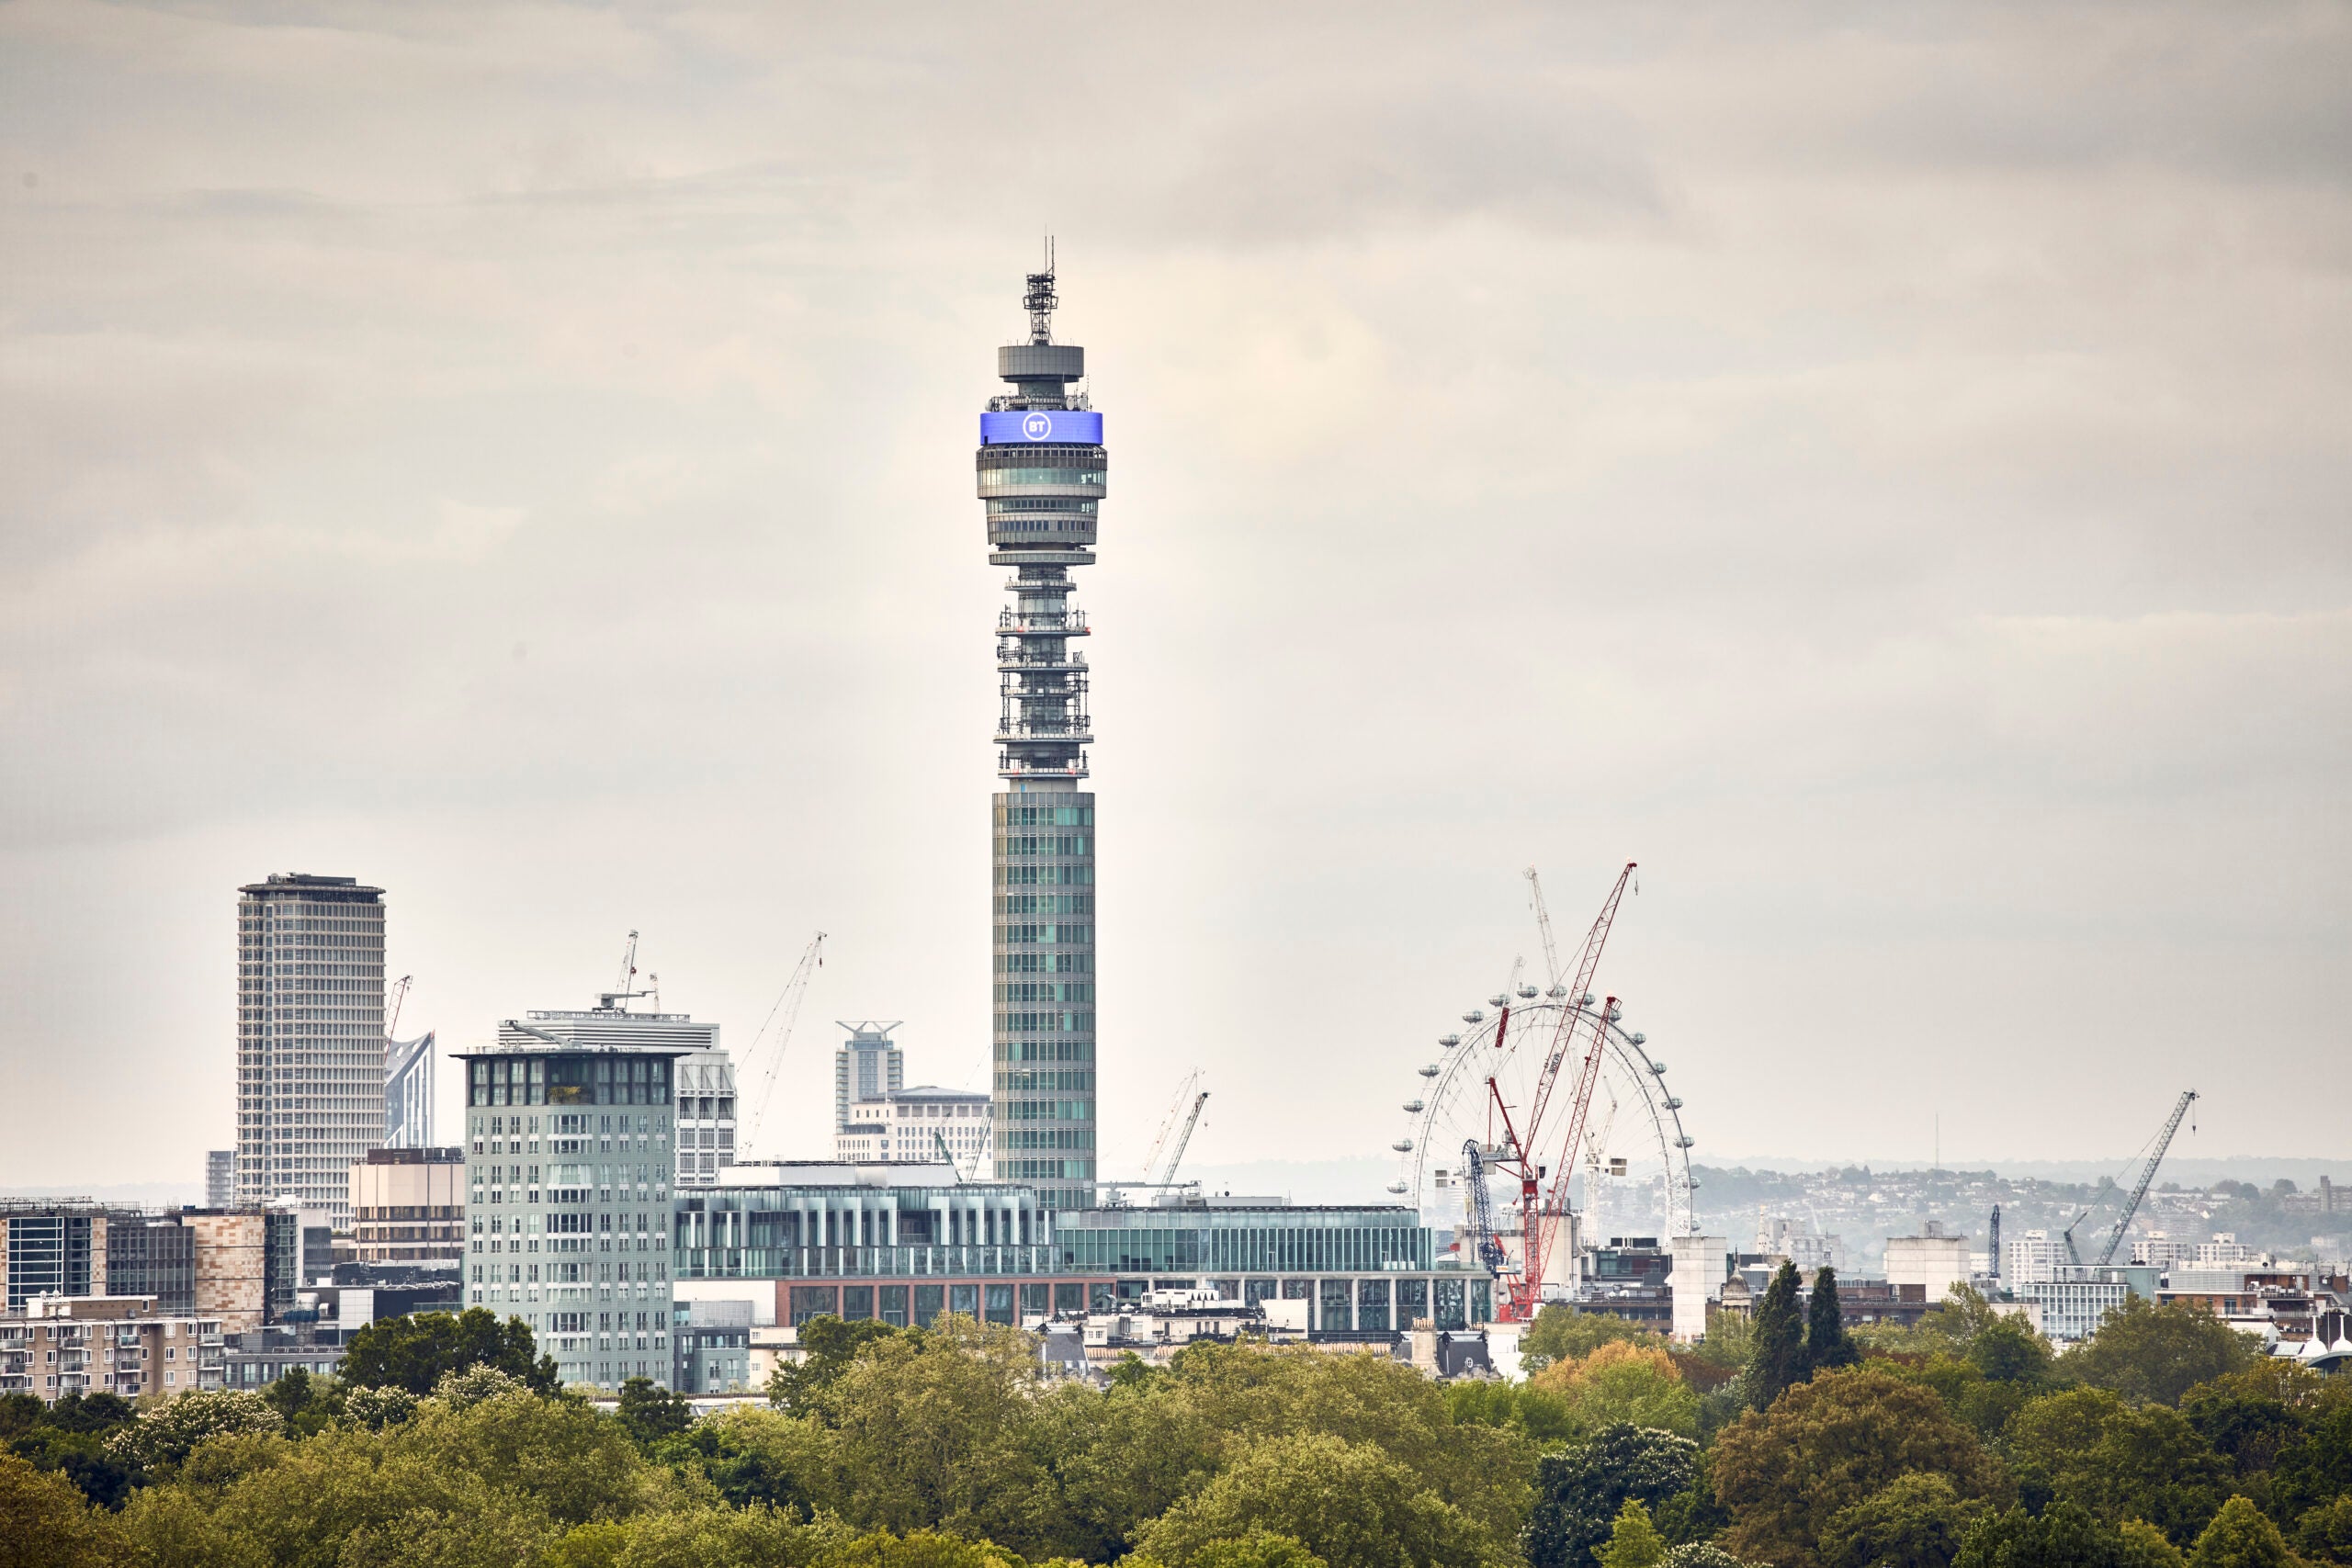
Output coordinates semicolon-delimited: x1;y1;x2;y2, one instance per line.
0;1277;2352;1568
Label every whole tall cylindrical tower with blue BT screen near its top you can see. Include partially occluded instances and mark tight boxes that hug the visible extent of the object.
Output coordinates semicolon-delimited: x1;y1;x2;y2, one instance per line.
978;252;1108;1208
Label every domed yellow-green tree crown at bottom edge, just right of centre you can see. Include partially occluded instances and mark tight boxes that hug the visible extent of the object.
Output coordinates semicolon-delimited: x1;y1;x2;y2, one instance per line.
1136;1434;1505;1568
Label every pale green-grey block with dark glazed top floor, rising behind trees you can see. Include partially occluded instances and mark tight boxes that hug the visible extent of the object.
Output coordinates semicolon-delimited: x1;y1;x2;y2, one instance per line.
457;1030;689;1387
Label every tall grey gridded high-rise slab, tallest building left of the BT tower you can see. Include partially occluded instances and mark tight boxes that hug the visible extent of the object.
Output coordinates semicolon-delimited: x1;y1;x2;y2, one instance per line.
235;872;383;1224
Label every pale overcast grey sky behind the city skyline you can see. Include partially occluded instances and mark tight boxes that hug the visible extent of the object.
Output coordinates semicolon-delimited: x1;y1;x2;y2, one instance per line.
0;0;2352;1185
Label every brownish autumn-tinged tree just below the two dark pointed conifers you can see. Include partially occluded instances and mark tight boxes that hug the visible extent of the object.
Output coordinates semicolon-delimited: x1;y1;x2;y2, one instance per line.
1710;1366;2004;1568
